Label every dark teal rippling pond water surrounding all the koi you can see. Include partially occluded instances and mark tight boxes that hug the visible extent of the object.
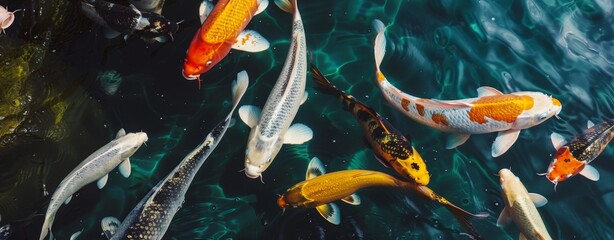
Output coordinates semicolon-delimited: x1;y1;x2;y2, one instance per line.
0;0;614;239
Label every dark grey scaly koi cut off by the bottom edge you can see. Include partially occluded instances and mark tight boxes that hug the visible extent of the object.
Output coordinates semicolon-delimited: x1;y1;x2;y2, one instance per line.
108;71;249;240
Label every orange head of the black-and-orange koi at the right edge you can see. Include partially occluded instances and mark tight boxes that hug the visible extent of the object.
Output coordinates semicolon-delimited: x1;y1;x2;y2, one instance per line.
546;146;586;184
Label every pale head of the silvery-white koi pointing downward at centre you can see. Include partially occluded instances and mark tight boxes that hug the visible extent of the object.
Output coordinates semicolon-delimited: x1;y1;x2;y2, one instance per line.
245;135;282;178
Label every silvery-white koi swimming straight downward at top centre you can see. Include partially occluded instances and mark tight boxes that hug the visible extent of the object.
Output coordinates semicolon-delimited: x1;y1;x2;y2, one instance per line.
239;0;313;178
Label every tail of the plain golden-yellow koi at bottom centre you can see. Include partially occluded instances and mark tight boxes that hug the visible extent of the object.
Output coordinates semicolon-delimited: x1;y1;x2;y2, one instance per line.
418;186;489;239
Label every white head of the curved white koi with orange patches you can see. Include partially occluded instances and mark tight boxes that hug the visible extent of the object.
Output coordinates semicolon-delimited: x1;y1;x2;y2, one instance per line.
516;92;562;129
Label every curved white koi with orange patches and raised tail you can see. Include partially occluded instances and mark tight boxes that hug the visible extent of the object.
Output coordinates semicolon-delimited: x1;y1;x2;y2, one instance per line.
373;20;561;157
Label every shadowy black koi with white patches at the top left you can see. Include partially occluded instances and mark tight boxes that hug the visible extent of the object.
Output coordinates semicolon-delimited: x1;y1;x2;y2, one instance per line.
81;0;179;42
